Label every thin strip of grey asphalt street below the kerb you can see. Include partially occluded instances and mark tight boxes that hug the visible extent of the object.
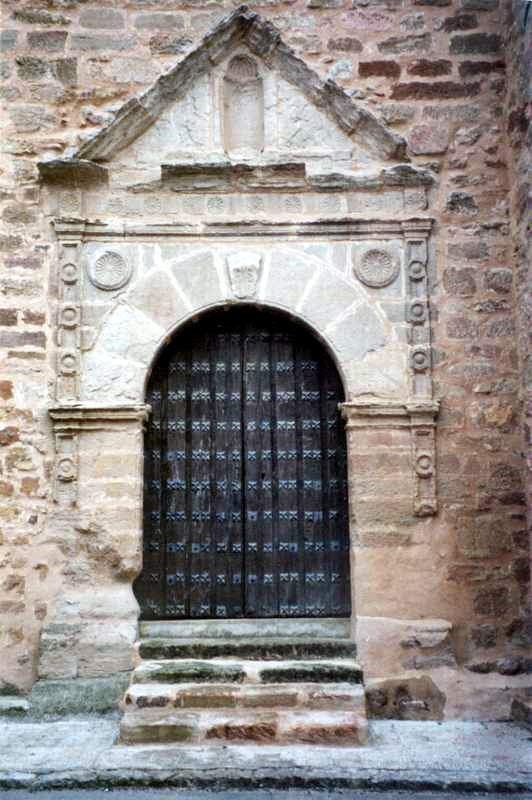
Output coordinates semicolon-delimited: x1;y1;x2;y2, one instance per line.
0;789;532;800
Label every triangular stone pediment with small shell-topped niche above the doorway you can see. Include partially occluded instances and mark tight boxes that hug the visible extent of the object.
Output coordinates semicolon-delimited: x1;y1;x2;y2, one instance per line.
74;6;406;169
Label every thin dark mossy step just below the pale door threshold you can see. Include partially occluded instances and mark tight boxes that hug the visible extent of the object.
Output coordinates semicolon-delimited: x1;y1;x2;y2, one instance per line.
139;637;357;661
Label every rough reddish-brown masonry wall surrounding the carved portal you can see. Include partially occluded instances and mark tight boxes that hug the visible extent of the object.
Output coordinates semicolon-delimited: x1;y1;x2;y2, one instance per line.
0;0;529;715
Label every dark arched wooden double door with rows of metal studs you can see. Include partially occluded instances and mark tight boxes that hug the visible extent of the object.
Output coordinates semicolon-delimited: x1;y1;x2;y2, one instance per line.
135;307;350;619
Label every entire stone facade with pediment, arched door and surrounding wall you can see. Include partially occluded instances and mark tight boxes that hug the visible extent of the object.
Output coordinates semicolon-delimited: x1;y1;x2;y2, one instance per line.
0;0;532;741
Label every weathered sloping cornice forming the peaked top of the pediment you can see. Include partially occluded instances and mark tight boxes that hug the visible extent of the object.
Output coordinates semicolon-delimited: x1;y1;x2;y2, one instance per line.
74;5;408;161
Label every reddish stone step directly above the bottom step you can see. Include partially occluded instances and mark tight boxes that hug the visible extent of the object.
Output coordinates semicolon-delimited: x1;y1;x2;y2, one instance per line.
122;683;366;718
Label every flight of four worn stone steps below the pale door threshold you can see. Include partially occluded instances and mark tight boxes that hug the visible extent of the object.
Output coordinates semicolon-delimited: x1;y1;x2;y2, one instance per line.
120;637;367;746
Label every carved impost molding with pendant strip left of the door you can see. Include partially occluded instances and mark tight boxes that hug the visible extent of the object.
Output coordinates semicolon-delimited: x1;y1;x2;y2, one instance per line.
48;404;151;507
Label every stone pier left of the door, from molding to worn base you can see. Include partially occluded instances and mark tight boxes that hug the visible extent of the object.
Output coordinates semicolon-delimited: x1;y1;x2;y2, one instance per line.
32;405;149;714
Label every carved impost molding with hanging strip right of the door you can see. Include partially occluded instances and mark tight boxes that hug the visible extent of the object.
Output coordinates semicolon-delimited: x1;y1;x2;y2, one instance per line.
340;398;439;517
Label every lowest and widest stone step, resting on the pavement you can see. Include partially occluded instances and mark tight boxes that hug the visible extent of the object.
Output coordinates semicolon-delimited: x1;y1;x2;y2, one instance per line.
120;708;367;746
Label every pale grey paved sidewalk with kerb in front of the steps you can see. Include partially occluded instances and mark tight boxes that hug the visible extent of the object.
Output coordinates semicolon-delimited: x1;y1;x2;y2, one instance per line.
0;717;532;800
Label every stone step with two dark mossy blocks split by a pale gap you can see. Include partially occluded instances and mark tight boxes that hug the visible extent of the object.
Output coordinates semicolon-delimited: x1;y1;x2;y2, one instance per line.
132;658;363;684
